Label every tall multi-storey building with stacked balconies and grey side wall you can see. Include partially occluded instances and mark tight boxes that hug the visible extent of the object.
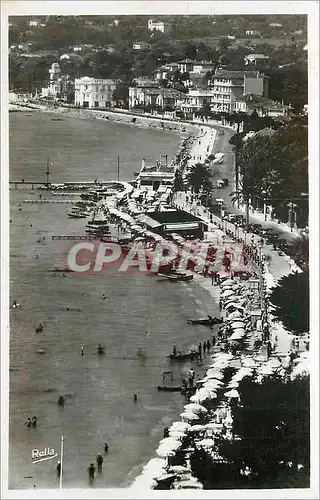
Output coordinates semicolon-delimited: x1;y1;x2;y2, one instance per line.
211;70;269;113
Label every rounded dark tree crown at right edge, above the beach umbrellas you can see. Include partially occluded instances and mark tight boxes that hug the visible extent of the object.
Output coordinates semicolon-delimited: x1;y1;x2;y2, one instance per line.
270;272;309;334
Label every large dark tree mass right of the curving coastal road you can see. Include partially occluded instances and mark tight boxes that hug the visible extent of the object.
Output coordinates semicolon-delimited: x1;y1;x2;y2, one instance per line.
234;118;308;226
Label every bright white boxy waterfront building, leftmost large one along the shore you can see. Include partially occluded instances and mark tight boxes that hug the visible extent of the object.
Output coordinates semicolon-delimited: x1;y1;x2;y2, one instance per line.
74;76;117;108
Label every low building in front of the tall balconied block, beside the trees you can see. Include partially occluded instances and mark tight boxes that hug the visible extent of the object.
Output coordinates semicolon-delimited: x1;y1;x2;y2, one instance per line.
234;94;290;118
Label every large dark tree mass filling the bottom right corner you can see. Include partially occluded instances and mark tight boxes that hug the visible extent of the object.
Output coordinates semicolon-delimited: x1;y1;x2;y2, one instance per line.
219;375;310;488
